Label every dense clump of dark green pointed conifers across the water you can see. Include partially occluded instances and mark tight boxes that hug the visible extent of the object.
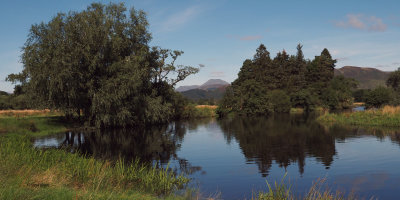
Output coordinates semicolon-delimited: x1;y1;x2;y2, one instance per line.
218;44;357;116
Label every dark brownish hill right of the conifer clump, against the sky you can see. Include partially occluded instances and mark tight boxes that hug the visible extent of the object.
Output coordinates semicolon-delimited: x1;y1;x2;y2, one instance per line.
335;66;390;89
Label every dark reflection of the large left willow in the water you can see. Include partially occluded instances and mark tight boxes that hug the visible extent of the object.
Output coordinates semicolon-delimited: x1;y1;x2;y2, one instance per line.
60;119;212;174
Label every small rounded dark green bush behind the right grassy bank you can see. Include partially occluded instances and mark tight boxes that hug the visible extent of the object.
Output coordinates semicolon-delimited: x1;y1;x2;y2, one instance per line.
365;86;393;108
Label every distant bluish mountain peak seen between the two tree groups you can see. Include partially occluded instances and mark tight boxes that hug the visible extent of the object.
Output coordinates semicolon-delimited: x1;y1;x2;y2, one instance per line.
176;79;229;101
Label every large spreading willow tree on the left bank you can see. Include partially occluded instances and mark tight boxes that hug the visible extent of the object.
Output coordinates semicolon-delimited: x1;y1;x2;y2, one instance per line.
8;3;198;127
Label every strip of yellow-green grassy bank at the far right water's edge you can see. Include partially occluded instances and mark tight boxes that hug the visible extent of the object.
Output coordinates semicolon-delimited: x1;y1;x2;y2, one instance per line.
317;106;400;127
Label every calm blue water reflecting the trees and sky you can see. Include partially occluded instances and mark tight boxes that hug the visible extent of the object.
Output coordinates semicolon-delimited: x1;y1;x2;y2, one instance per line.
34;115;400;199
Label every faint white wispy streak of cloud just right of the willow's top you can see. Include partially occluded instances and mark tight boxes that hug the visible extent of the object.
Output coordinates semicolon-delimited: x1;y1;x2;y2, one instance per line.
161;6;204;31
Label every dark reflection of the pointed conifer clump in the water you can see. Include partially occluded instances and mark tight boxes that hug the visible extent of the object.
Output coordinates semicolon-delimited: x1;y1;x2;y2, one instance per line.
220;115;336;177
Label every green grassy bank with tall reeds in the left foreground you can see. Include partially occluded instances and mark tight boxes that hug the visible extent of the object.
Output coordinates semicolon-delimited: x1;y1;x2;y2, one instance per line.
0;115;189;199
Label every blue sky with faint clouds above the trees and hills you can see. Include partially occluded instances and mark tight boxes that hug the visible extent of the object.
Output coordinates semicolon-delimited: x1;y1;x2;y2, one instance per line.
0;0;400;92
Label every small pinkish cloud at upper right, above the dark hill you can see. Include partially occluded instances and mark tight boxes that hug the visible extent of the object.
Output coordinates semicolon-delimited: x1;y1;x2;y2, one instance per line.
335;14;387;32
